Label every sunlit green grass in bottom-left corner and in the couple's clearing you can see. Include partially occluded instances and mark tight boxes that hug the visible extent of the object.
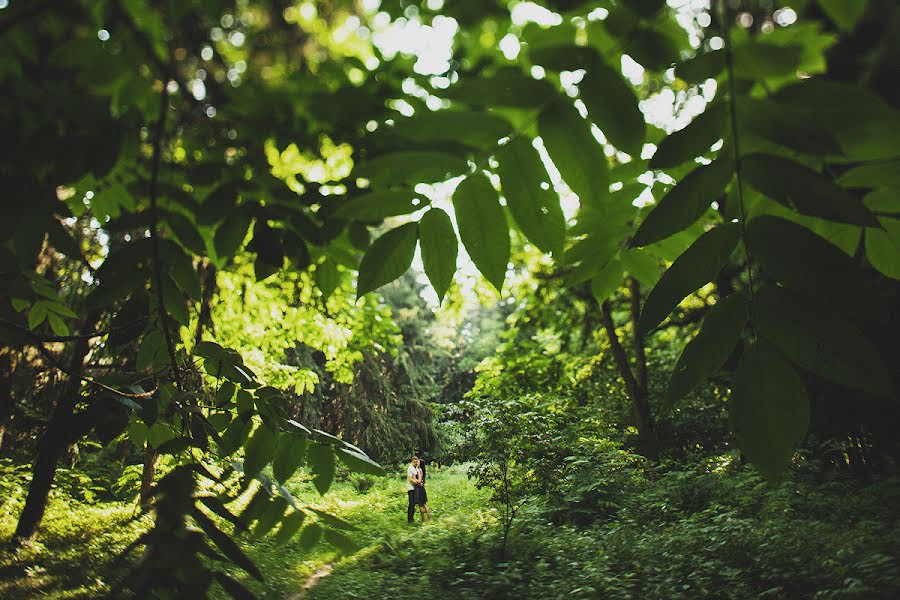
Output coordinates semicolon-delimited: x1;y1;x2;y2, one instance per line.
0;467;494;600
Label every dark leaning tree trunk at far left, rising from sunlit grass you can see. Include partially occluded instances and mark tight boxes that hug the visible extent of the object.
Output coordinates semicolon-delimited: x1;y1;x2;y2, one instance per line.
13;312;99;542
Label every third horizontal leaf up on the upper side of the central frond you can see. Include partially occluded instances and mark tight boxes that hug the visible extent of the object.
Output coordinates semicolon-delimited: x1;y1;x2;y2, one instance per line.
394;110;513;150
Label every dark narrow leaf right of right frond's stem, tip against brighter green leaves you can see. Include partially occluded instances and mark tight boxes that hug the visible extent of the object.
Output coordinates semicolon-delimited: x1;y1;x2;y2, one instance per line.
741;154;877;226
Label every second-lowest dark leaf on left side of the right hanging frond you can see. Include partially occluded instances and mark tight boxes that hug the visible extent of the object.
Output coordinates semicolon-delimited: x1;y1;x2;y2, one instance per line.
638;223;740;334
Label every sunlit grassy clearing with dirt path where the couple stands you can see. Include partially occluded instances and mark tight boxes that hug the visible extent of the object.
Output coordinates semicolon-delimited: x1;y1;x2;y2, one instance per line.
235;467;486;599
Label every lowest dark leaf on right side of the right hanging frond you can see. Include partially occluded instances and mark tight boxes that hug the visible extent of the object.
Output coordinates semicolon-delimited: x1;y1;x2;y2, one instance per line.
753;287;893;397
